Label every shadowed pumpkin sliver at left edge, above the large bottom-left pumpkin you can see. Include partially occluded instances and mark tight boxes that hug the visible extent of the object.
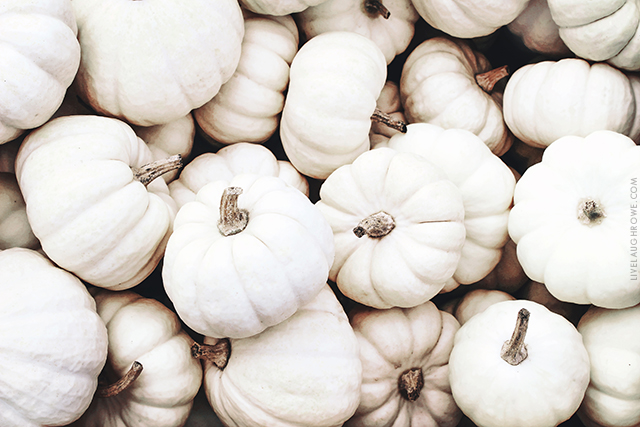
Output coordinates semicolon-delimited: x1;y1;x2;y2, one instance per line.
0;172;40;250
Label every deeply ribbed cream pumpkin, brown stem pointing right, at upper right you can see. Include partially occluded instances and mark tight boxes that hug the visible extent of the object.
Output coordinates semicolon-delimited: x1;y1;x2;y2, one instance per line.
400;37;513;156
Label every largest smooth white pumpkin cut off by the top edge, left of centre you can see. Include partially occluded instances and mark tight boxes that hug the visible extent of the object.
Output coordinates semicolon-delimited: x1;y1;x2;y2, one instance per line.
72;0;244;126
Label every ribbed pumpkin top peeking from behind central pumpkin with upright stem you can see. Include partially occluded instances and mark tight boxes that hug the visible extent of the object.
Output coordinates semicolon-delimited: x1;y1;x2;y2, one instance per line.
169;142;309;207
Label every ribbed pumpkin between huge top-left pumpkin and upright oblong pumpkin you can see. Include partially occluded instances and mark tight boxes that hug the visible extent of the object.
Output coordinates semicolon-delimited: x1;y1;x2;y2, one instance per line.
194;15;299;144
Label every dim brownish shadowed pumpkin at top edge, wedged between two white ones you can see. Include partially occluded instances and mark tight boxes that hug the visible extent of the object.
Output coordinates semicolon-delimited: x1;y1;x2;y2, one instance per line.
507;0;571;57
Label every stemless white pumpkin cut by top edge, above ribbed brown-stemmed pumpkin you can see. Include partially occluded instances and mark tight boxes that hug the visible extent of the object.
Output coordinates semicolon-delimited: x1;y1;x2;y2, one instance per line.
413;0;529;39
